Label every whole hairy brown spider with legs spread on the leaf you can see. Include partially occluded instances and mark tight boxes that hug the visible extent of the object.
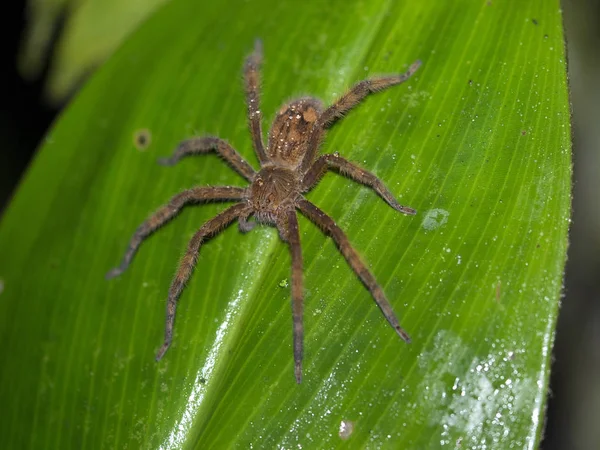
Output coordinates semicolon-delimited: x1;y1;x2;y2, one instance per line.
106;41;421;383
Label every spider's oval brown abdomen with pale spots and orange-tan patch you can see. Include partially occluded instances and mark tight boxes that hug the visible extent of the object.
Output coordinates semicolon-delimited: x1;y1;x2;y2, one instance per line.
267;97;323;168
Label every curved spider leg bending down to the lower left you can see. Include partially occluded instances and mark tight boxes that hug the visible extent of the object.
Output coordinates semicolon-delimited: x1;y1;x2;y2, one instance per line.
156;203;248;361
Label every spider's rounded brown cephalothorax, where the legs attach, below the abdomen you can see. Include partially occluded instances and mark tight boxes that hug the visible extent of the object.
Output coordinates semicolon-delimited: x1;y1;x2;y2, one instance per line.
250;166;299;223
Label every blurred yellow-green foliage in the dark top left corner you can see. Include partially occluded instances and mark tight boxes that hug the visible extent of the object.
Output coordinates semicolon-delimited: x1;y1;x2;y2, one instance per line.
19;0;165;104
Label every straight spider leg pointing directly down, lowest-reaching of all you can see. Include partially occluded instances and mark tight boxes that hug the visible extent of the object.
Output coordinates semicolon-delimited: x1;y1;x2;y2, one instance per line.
286;209;304;384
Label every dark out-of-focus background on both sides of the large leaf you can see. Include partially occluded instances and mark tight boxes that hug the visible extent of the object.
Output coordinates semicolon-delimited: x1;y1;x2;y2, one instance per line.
0;0;600;450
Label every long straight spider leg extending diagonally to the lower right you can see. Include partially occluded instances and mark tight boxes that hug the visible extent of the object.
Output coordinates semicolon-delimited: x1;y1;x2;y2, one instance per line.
297;199;410;342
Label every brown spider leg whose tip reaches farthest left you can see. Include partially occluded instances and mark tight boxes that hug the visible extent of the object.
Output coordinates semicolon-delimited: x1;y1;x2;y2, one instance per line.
106;186;246;279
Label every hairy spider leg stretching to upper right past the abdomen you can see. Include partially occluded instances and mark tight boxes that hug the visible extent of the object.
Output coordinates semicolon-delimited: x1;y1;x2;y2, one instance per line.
301;61;421;172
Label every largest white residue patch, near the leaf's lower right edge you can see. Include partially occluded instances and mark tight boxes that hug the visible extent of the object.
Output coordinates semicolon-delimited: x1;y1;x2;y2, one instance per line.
418;330;539;449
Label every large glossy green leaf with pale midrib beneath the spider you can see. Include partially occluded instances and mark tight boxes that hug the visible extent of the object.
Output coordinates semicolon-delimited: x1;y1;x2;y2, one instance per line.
0;0;571;449
